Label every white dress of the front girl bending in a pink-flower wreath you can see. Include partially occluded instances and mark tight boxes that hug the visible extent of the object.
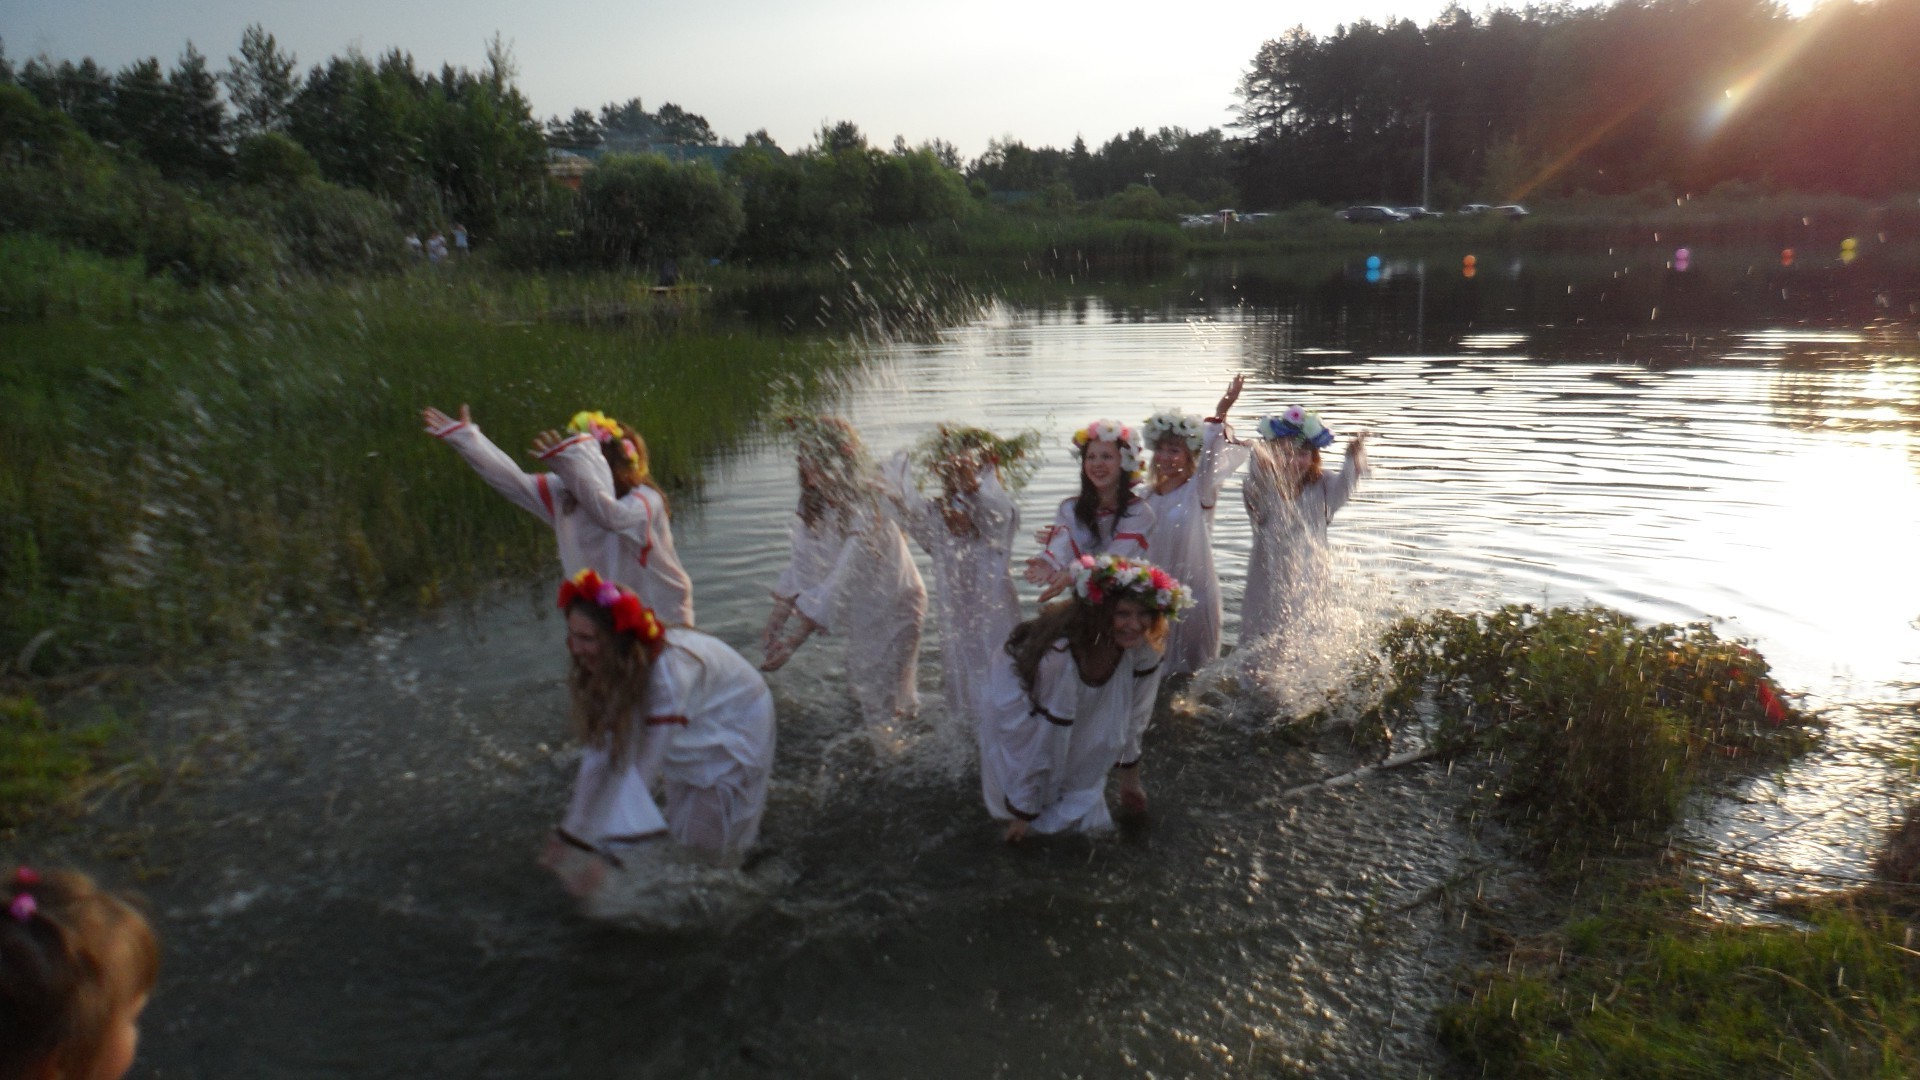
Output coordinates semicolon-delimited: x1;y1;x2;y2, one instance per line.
979;638;1160;832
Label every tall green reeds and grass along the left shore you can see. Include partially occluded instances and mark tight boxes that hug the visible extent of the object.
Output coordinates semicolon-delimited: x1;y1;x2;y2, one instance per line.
0;271;849;673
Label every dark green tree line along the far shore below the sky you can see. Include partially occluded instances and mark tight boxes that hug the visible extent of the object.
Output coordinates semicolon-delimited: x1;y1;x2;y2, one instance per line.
0;0;1920;290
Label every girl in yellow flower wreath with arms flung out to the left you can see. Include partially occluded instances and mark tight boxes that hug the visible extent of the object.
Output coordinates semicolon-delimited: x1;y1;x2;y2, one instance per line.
420;405;693;626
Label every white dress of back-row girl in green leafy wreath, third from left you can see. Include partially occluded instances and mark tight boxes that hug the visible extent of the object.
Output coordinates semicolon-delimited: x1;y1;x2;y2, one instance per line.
887;452;1020;726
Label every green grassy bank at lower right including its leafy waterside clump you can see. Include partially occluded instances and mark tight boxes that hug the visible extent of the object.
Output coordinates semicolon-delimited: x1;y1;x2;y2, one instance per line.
1380;605;1920;1078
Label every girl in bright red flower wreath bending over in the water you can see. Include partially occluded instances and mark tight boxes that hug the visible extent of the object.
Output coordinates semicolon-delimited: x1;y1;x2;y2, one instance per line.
543;571;774;896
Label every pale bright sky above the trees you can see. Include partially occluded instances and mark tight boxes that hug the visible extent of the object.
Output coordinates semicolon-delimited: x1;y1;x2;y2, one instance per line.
0;0;1811;158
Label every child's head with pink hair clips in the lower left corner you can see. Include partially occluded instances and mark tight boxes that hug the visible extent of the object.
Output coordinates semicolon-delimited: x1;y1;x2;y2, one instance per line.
0;867;159;1080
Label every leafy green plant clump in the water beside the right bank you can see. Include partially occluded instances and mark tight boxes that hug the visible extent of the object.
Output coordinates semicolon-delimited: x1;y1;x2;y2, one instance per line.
1377;603;1820;855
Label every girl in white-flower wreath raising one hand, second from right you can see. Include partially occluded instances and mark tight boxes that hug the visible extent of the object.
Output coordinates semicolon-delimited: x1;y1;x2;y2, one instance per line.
1142;377;1248;678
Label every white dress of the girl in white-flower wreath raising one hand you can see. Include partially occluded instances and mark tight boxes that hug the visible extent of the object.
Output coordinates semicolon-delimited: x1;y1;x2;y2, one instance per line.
1146;421;1250;675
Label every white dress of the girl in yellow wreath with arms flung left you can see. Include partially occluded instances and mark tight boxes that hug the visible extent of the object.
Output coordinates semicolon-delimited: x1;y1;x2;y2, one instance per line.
434;423;693;626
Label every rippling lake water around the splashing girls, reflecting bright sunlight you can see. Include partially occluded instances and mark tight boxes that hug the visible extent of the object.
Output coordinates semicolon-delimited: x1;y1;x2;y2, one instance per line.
127;252;1920;1078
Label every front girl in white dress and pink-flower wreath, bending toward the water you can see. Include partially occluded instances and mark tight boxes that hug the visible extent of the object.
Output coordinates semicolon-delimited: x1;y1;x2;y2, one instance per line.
979;555;1192;844
